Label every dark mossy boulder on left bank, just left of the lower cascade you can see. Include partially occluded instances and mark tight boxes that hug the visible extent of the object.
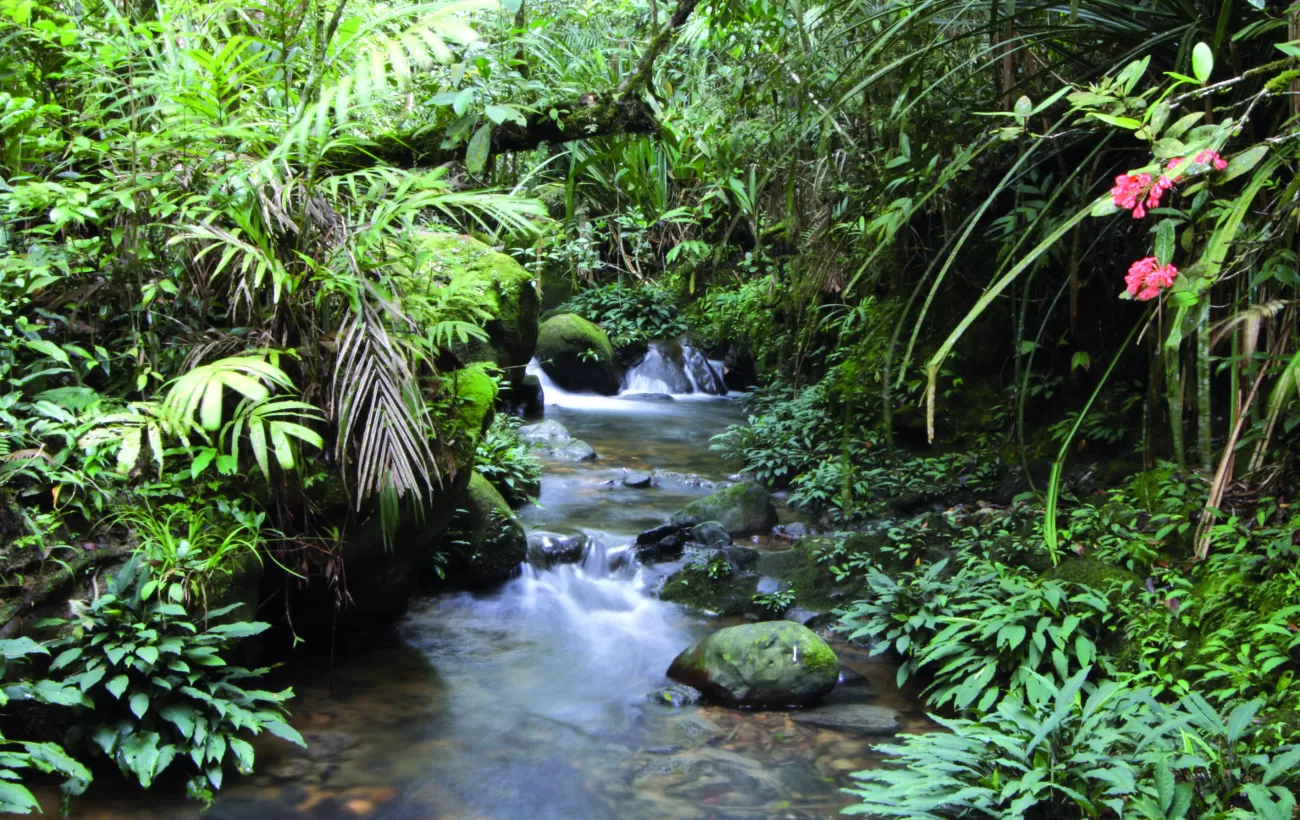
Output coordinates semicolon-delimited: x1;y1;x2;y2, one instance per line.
443;472;528;587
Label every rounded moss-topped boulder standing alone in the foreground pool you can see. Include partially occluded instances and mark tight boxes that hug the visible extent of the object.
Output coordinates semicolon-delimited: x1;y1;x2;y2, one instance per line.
668;621;840;708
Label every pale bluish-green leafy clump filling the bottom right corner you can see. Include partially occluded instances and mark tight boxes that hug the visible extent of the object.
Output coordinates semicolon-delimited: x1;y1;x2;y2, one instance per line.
846;668;1300;820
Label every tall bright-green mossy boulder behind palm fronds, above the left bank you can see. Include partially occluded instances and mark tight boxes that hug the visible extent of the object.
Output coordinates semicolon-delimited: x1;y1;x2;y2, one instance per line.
394;233;540;385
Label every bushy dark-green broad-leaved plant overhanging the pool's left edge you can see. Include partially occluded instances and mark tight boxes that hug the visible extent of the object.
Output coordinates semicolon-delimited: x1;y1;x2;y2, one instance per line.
49;555;304;801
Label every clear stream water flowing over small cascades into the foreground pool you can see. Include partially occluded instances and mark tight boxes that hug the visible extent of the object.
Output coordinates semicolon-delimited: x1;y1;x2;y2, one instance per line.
35;366;919;820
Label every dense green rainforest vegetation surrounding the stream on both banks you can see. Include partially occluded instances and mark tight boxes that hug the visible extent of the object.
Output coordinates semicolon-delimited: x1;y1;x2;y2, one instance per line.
0;0;1300;820
